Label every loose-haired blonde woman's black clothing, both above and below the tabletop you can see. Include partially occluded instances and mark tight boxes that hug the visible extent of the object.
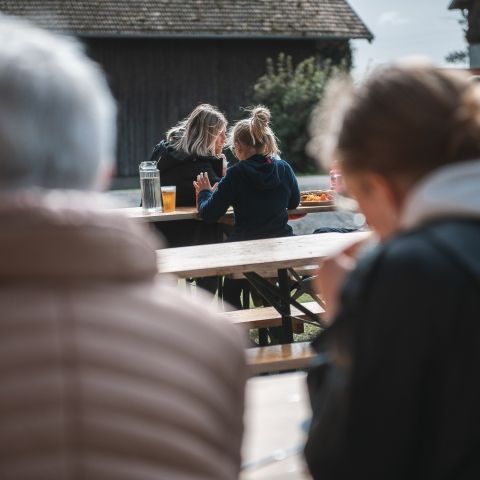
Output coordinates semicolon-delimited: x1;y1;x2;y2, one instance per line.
150;140;223;247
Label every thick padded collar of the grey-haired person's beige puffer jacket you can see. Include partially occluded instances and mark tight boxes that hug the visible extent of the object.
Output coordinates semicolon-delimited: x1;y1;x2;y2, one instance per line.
0;191;159;283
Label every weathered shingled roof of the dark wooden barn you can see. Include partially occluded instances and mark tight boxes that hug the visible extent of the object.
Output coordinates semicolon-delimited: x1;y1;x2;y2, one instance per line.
0;0;373;40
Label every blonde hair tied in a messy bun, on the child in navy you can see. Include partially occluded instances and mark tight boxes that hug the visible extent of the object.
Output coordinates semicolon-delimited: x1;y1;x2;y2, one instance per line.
227;105;280;156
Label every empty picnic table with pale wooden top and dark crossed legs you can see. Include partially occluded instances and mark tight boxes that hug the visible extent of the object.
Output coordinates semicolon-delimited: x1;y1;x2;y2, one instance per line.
157;232;370;343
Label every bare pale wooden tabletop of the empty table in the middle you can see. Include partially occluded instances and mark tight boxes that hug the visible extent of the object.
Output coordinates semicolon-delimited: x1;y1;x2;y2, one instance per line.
157;232;370;278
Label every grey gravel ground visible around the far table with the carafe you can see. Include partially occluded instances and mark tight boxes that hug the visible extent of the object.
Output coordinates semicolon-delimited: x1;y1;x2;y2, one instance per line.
108;175;356;235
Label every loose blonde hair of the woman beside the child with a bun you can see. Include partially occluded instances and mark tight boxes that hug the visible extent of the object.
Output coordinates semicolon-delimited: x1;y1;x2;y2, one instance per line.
171;103;227;156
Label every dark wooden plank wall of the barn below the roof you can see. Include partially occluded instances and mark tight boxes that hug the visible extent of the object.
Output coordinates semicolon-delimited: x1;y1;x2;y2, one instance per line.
86;38;344;186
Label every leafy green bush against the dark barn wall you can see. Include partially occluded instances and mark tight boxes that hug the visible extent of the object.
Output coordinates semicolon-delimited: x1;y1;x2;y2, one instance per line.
252;53;345;173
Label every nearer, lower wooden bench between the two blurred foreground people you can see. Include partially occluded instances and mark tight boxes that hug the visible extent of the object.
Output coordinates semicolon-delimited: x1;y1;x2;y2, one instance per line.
246;342;315;375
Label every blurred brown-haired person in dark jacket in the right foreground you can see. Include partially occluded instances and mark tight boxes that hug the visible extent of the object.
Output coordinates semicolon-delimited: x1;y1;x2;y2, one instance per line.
305;62;480;480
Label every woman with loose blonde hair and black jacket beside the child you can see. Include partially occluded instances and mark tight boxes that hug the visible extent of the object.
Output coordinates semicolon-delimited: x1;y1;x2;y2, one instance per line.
150;104;227;291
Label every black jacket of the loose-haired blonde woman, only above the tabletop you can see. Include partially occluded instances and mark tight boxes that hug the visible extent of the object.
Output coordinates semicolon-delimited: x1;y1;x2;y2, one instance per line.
150;140;223;207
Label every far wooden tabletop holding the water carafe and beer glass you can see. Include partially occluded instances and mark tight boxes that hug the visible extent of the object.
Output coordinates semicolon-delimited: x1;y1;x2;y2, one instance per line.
112;205;335;222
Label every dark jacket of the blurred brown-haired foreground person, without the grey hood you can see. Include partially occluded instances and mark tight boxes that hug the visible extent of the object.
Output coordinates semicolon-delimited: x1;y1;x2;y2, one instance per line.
305;219;480;480
